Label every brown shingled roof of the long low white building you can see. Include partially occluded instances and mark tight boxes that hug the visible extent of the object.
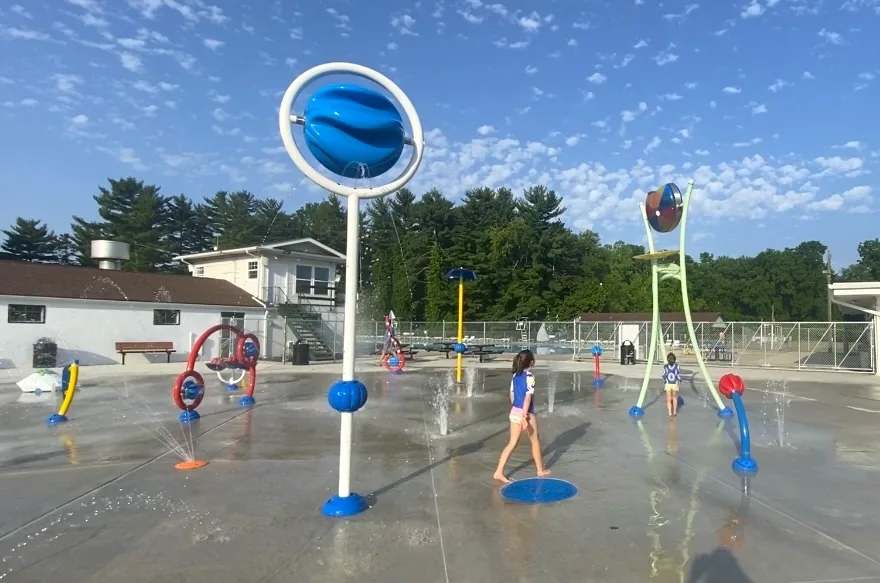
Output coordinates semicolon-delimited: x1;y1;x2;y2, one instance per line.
0;260;262;308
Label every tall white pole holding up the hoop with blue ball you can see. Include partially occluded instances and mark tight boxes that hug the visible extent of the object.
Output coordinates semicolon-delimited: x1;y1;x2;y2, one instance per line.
339;196;361;498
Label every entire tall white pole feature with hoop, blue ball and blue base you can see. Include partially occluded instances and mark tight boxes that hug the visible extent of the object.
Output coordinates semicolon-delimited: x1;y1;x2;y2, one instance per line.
278;63;424;517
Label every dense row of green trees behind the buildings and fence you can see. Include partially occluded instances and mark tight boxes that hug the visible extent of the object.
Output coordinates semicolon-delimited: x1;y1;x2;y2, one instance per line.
2;178;880;321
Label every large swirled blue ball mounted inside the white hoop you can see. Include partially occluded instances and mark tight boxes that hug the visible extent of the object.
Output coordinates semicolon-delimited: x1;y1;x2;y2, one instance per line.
304;84;406;178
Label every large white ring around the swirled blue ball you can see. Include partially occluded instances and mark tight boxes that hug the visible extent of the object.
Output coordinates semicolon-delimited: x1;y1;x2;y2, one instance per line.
278;63;425;198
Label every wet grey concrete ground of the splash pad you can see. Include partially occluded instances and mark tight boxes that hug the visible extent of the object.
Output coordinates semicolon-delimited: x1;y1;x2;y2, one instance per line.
0;366;880;583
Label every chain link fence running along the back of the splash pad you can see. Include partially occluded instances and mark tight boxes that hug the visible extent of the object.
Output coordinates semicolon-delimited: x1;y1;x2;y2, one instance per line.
350;314;876;372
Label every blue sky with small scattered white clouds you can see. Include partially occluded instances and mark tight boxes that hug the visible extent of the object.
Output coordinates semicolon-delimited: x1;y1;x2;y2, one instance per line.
0;0;880;268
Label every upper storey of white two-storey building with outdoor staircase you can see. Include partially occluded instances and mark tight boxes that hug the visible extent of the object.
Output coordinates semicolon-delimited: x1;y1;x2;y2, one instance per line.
177;239;345;309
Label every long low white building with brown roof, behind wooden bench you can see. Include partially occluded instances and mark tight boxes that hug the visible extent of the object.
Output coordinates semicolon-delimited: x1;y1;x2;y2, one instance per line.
0;260;268;369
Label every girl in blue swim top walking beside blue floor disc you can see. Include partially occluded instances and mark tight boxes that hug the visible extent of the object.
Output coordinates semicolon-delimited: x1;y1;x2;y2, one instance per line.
494;350;550;484
